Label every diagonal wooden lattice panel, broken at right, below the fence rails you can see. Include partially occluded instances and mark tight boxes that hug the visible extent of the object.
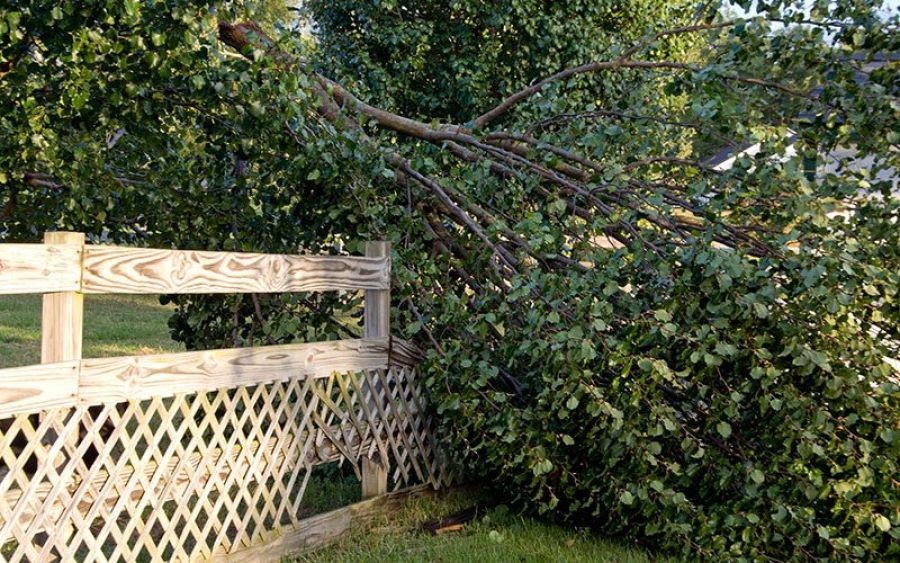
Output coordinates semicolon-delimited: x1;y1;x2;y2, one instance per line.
0;367;448;561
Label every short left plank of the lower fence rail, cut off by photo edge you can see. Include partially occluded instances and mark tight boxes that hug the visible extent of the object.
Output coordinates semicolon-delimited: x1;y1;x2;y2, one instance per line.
0;360;78;418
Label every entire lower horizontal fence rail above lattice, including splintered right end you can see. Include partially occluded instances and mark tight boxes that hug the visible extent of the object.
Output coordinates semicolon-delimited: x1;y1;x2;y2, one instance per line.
0;337;421;418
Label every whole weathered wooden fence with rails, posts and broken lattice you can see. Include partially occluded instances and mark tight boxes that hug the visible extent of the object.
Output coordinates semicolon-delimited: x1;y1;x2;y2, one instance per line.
0;233;446;561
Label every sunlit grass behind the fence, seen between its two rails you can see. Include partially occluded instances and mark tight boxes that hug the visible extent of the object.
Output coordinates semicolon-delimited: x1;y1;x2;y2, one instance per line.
0;295;184;368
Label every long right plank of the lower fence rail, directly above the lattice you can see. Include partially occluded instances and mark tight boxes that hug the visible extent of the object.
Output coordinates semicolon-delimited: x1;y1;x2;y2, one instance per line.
78;338;388;405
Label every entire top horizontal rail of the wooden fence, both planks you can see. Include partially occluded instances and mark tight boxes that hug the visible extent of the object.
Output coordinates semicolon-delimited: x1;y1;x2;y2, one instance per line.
0;244;391;295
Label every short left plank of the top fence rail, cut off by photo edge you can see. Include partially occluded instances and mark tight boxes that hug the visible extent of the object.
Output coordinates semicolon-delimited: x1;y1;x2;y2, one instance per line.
0;244;81;295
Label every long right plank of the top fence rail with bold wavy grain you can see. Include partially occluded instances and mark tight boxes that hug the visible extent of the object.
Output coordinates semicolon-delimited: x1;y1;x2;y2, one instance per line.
82;246;390;294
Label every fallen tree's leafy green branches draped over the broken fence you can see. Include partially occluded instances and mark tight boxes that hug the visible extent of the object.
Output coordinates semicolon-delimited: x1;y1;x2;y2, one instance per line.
0;0;900;559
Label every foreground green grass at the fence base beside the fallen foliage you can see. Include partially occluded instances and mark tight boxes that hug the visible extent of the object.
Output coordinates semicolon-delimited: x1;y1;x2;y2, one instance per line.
283;491;660;563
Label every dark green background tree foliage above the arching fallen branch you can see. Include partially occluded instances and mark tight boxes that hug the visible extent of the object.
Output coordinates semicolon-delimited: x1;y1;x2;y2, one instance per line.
304;0;696;123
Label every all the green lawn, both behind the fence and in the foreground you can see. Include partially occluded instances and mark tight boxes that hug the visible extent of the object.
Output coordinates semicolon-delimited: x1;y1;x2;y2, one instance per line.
0;295;654;563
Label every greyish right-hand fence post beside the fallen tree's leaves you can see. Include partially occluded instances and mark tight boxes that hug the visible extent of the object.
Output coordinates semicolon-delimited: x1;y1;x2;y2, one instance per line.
362;241;391;498
